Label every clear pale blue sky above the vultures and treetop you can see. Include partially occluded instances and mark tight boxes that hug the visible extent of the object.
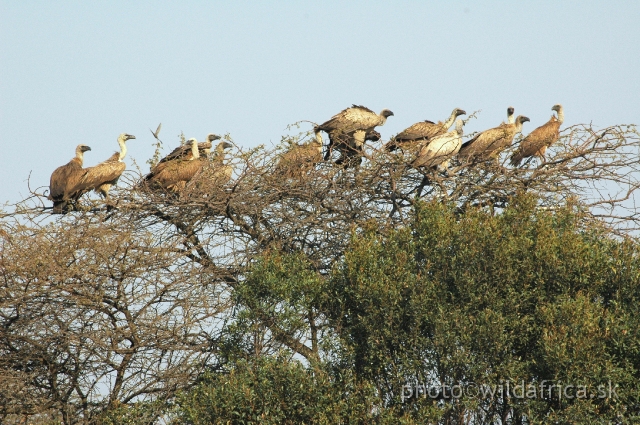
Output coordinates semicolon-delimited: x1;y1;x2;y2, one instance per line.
0;0;640;203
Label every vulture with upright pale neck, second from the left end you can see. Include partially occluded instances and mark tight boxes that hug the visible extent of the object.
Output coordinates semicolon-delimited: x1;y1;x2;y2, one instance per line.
73;133;136;201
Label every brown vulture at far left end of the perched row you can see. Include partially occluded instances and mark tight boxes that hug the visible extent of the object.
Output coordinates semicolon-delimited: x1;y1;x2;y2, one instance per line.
47;145;91;214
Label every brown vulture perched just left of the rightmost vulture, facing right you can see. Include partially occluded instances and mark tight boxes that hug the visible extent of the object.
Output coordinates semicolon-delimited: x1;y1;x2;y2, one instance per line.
458;115;529;162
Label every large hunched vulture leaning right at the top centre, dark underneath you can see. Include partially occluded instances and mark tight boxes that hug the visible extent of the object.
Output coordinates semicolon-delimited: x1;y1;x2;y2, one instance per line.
313;105;393;162
